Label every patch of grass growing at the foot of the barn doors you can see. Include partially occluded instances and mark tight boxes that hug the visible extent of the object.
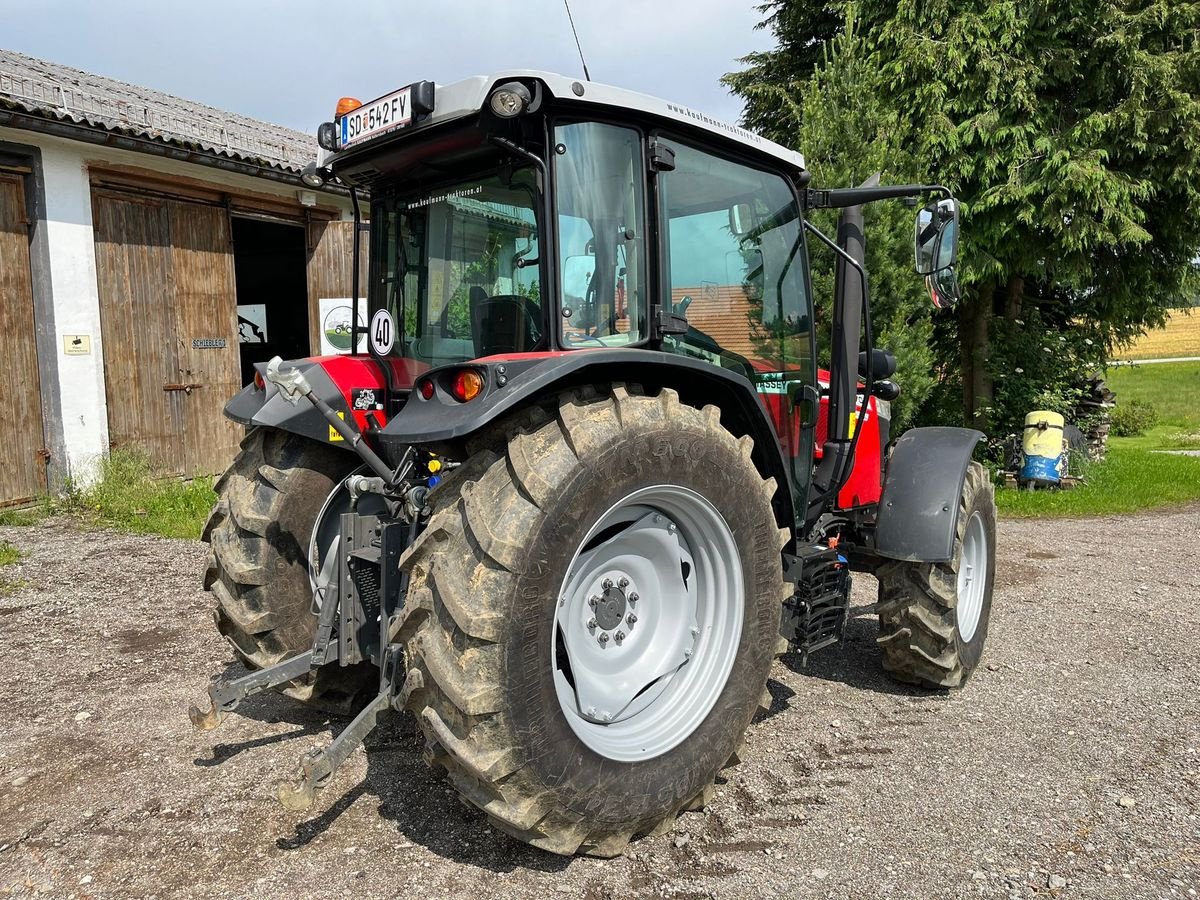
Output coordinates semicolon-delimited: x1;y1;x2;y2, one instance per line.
49;450;217;540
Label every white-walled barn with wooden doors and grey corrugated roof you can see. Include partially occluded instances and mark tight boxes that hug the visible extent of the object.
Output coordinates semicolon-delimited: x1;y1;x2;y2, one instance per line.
0;50;365;505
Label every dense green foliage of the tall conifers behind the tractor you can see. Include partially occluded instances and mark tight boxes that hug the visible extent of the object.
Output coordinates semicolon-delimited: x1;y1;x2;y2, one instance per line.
728;0;1200;439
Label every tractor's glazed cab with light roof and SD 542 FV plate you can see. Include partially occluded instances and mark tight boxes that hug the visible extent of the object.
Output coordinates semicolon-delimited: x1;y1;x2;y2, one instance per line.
312;72;817;513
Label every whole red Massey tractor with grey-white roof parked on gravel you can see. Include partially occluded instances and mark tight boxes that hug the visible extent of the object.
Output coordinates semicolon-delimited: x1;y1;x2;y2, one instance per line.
192;71;995;856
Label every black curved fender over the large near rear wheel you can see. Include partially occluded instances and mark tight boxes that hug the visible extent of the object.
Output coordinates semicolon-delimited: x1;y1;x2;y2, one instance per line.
380;349;796;529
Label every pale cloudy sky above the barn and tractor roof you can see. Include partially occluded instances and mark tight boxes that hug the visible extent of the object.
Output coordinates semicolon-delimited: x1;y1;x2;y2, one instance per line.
0;0;772;132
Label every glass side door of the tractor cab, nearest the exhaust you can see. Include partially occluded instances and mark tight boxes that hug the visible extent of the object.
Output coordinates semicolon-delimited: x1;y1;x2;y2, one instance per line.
656;137;818;518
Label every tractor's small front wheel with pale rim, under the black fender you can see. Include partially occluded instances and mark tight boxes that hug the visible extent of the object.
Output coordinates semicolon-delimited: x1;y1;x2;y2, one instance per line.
876;462;996;688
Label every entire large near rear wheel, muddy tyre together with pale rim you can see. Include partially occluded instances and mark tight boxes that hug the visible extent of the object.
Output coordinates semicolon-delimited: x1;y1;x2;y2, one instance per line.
400;386;787;857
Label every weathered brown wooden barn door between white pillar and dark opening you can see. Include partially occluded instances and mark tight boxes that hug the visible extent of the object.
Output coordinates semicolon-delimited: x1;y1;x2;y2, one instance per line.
92;191;240;475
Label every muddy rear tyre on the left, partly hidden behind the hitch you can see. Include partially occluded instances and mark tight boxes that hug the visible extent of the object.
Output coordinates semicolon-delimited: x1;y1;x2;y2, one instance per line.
202;428;378;713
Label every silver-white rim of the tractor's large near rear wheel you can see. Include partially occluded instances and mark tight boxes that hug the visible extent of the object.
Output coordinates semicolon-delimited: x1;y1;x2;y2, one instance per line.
551;485;745;762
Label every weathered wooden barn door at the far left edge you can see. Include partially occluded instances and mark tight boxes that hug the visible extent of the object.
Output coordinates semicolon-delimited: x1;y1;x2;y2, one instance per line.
0;172;46;505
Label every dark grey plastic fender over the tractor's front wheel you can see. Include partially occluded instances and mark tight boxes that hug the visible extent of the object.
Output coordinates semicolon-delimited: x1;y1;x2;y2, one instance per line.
875;427;983;563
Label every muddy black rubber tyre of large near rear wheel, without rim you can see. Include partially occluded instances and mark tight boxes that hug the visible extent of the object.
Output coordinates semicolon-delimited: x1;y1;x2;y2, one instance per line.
400;386;787;856
